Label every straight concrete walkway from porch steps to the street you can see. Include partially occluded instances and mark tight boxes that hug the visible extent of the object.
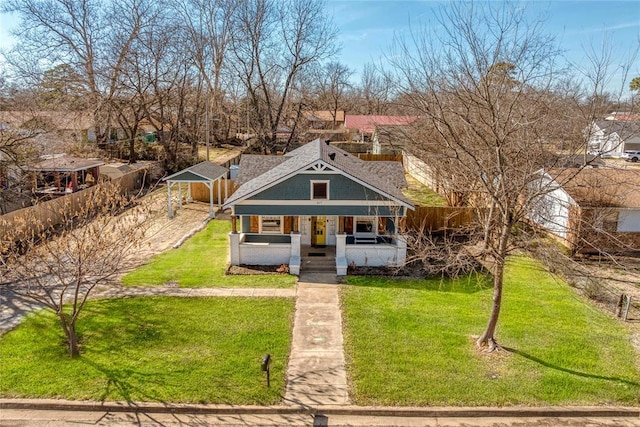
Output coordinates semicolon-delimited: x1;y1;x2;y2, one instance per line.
284;273;350;406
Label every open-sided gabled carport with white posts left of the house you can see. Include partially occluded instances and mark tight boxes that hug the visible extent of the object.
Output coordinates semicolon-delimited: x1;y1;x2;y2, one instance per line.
164;161;229;218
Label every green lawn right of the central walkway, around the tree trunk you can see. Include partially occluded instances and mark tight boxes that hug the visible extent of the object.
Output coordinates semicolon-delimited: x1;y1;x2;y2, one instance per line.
342;258;640;406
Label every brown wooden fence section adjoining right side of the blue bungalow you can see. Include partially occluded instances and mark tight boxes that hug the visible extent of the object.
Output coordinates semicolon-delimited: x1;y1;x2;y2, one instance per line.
407;206;475;232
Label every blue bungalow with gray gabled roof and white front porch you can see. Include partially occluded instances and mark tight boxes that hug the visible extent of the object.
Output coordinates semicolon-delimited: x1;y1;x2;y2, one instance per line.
224;140;413;275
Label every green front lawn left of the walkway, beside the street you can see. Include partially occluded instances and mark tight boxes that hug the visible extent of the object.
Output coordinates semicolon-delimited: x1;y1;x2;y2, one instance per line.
0;297;294;405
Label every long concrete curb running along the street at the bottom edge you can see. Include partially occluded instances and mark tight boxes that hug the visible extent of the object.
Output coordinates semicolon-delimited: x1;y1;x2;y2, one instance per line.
0;399;640;418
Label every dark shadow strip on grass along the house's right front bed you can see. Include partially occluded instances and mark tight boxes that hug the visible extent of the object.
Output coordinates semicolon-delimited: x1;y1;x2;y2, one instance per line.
347;274;493;294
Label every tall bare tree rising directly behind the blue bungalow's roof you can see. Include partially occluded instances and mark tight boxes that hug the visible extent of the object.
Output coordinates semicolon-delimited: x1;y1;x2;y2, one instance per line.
232;0;336;151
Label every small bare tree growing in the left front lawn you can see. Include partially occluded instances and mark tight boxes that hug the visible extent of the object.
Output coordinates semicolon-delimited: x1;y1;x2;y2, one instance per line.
0;184;147;357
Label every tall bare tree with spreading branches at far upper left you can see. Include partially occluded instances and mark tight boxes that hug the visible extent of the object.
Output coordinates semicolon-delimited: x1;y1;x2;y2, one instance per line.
0;0;151;143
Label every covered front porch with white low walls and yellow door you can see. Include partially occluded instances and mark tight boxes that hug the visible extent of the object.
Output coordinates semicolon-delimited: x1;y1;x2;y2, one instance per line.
229;215;406;275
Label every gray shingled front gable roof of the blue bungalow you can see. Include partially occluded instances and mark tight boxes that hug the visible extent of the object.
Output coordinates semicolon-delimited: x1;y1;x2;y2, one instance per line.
225;139;412;207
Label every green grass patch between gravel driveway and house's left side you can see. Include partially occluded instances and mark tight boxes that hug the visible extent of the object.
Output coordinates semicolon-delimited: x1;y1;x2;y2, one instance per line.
122;220;296;288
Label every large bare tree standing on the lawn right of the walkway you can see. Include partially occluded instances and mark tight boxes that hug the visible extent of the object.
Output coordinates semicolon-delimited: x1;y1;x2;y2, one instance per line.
390;3;604;350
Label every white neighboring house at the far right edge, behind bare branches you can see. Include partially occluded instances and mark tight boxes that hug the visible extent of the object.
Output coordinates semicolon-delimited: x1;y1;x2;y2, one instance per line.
588;120;640;157
